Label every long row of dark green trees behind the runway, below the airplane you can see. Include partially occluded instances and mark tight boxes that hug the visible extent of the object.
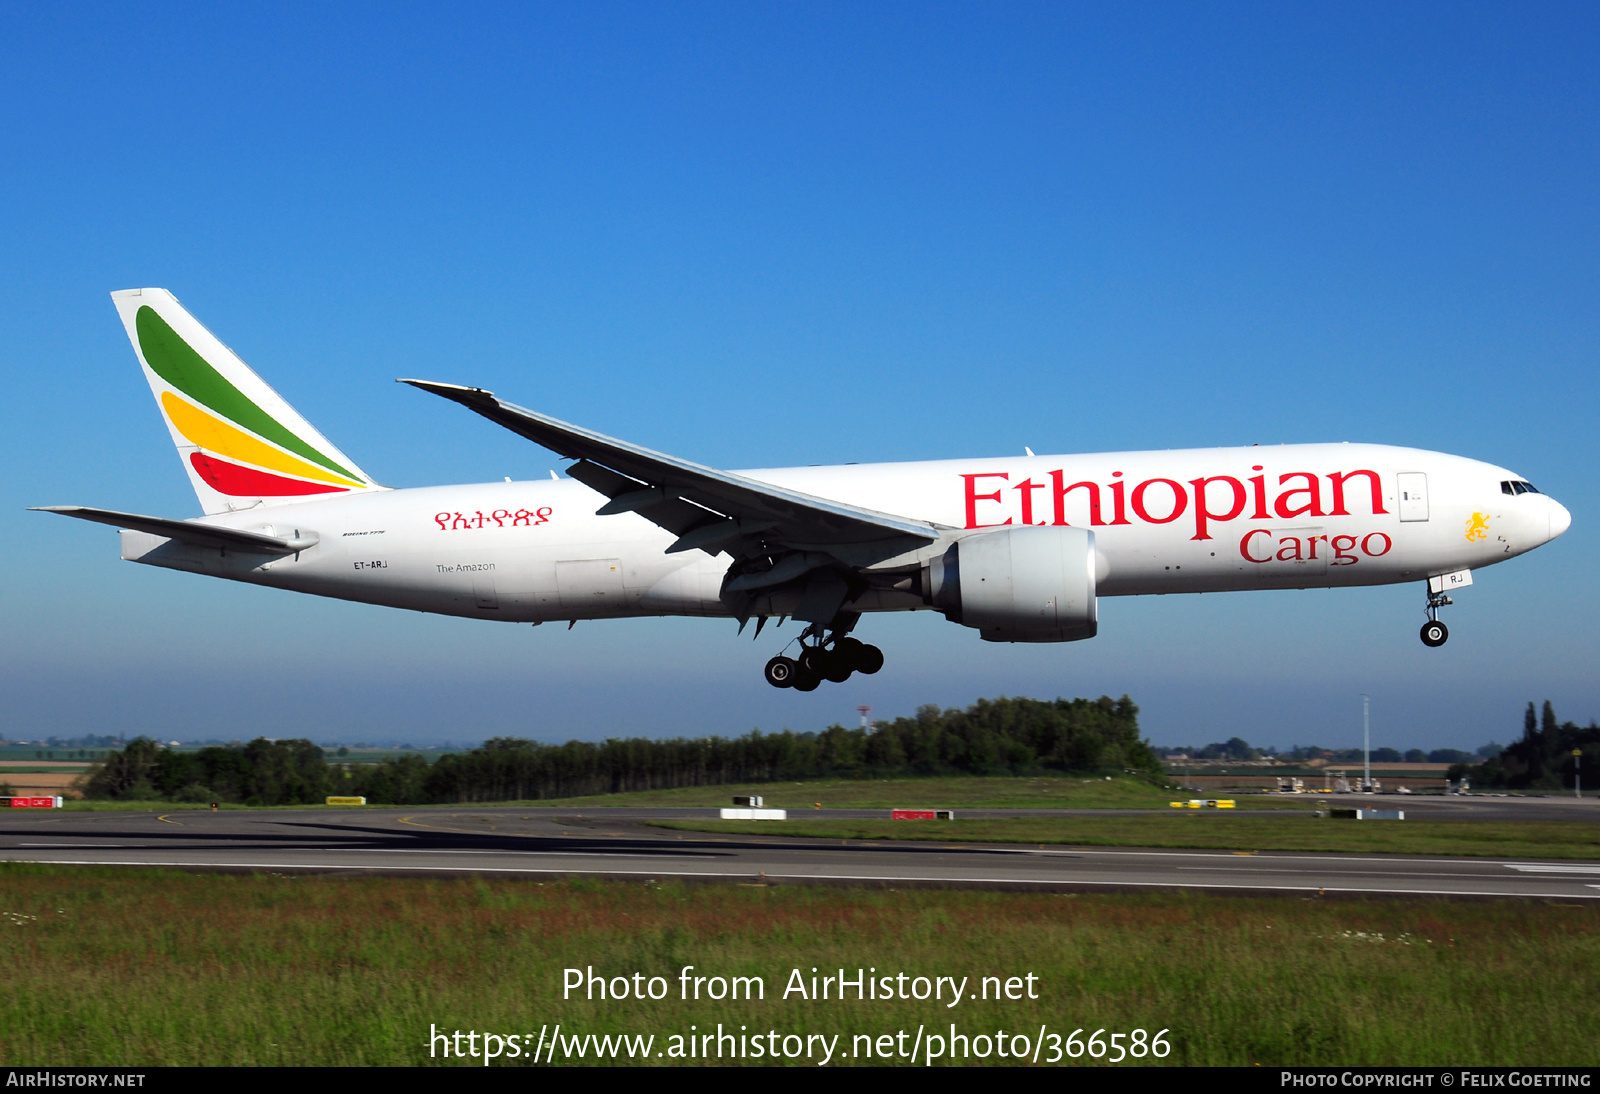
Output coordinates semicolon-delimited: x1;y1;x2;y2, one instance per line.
85;696;1162;805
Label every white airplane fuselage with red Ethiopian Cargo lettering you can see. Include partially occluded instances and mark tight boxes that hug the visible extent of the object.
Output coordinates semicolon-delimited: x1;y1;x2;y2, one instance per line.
122;445;1570;622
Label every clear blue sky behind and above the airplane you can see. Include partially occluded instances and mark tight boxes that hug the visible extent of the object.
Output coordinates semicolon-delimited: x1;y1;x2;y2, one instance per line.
0;3;1600;747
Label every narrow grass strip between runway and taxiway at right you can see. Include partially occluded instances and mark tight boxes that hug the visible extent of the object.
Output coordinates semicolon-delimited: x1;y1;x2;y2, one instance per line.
650;811;1600;860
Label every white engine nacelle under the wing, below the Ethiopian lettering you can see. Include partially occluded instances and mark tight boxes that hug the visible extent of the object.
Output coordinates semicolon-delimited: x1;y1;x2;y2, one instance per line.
922;526;1099;641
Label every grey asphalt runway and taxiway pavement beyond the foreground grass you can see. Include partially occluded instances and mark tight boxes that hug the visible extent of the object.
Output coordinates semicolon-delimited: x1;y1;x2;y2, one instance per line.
0;800;1600;900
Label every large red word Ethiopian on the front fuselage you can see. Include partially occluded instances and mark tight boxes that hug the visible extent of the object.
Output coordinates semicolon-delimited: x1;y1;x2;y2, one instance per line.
962;464;1389;539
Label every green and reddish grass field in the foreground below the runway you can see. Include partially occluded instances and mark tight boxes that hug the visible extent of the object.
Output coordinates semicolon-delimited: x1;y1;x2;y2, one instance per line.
0;865;1600;1067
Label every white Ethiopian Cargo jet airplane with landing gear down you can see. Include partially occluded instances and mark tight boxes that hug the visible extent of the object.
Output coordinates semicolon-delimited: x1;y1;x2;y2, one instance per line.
40;288;1571;691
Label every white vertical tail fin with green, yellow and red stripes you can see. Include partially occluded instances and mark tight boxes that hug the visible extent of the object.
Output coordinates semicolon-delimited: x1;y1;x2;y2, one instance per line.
110;288;384;515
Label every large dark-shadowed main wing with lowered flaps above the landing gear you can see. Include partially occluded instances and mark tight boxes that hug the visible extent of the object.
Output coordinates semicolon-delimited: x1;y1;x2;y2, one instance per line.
400;379;944;569
